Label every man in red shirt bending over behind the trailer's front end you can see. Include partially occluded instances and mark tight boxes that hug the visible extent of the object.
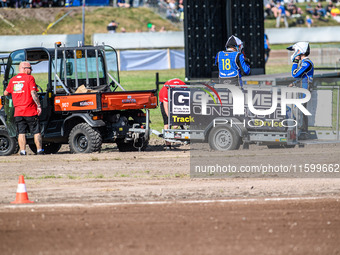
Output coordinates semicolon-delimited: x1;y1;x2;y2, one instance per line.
158;78;186;150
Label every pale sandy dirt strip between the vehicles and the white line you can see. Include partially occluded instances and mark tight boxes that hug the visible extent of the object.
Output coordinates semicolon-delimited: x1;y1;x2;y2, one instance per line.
0;142;340;205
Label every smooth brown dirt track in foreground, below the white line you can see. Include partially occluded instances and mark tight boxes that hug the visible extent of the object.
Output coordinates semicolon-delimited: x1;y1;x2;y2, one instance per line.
0;199;340;254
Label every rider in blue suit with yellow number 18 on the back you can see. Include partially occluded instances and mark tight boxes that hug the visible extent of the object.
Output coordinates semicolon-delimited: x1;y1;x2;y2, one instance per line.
215;35;250;87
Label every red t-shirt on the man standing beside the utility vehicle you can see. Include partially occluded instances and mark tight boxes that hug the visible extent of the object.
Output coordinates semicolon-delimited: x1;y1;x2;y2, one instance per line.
6;73;38;117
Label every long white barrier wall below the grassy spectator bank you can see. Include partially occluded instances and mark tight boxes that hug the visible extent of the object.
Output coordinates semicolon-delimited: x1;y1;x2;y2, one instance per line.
0;26;340;52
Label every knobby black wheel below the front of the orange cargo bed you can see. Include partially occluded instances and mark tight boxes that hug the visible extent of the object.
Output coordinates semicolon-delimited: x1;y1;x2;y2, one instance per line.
68;123;102;153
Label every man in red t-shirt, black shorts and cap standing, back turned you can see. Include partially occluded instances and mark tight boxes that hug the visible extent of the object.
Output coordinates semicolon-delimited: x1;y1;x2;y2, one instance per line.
4;62;44;155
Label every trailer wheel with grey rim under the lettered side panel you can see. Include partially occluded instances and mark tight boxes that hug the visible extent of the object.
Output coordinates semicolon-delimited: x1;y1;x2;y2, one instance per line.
208;126;241;151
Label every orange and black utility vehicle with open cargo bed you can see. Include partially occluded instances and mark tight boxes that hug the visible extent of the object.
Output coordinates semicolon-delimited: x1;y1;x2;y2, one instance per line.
0;43;158;156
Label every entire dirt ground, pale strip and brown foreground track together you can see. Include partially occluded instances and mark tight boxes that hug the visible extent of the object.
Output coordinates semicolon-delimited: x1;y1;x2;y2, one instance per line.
0;143;340;254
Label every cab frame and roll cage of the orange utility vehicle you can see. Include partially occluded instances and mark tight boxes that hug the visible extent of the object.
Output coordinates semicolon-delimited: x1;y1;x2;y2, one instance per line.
0;43;126;94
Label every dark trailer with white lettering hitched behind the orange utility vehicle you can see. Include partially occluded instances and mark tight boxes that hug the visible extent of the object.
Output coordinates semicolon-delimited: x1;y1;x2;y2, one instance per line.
156;73;340;151
